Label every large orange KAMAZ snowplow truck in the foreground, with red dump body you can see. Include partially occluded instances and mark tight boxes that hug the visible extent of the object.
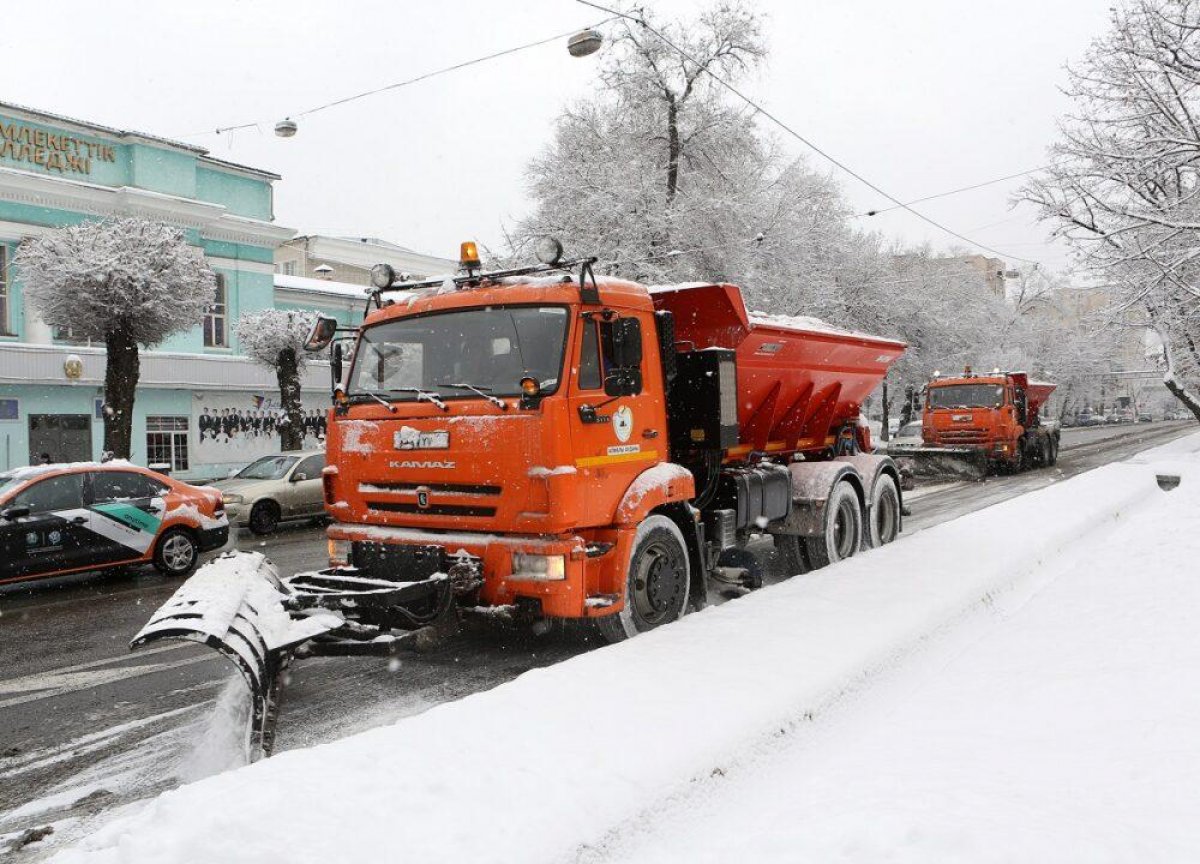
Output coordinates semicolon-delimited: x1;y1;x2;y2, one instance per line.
136;241;905;758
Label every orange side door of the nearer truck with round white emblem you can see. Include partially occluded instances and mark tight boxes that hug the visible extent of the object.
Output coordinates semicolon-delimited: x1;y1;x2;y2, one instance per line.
569;314;667;524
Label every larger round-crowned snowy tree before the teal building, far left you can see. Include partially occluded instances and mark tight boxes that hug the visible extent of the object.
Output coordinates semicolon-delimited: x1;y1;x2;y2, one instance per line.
13;218;216;458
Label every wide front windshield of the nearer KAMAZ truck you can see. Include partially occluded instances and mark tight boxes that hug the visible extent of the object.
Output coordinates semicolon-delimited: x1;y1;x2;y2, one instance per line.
347;306;568;401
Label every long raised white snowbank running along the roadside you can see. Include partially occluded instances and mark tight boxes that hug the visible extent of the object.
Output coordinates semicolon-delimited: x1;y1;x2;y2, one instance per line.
55;437;1200;864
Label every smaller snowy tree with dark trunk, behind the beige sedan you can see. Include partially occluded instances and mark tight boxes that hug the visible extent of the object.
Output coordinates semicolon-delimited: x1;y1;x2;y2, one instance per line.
236;310;317;450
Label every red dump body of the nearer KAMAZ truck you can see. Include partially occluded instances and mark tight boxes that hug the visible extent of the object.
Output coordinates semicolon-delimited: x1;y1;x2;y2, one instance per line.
650;284;905;457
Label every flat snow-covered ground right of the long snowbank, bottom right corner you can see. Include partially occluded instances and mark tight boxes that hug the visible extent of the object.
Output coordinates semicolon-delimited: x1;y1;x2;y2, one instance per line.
602;432;1200;864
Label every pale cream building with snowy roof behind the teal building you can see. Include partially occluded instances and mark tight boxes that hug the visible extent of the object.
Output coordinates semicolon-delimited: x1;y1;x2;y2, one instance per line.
275;234;458;286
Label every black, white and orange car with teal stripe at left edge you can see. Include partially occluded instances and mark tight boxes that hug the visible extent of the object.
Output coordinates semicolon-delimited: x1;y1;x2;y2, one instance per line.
0;461;229;583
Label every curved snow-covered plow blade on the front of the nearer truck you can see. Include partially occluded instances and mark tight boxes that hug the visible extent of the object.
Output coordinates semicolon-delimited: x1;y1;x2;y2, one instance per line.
130;552;343;758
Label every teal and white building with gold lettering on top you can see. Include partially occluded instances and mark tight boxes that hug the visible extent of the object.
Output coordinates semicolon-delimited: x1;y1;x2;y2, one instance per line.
0;103;366;479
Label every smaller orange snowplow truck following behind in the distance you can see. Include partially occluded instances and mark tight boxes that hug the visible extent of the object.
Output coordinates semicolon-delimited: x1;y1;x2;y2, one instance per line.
898;366;1060;479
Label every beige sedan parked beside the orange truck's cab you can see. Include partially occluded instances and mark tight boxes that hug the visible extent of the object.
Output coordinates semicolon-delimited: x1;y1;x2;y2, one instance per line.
212;450;325;534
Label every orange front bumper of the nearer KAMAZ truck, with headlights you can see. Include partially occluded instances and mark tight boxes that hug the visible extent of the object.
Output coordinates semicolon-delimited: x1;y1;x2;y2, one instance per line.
326;523;632;618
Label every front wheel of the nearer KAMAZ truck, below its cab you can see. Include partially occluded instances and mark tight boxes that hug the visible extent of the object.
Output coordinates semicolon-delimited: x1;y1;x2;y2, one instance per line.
596;514;690;642
